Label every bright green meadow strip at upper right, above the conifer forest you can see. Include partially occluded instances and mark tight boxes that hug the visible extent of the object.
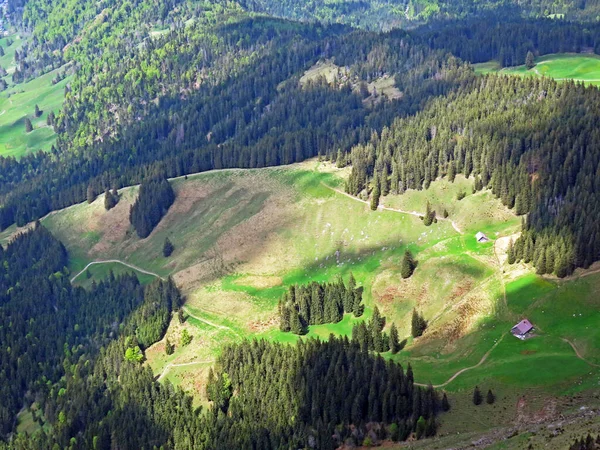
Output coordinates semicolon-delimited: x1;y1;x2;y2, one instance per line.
474;53;600;85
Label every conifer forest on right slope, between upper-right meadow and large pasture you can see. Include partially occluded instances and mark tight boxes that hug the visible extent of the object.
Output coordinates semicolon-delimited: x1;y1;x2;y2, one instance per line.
347;76;600;276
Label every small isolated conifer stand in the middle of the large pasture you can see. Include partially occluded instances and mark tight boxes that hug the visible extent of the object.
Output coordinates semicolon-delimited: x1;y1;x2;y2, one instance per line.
279;274;364;334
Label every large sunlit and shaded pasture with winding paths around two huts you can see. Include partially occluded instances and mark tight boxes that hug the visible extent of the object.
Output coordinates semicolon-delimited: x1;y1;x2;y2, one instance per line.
18;161;600;436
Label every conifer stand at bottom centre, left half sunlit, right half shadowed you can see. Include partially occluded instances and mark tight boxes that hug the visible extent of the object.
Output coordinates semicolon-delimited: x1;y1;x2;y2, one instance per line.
207;336;441;449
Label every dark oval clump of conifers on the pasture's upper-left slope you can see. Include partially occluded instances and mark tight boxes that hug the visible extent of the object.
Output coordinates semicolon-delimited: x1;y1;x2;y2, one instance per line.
129;175;175;239
